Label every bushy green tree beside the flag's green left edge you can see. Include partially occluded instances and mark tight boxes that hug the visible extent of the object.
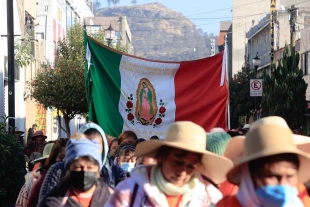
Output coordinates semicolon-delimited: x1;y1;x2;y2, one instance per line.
32;24;126;137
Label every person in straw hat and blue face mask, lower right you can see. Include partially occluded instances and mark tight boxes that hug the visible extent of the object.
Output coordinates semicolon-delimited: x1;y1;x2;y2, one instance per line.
217;117;310;207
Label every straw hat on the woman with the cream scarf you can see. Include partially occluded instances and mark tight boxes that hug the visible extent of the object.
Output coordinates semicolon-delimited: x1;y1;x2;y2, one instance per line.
135;121;233;183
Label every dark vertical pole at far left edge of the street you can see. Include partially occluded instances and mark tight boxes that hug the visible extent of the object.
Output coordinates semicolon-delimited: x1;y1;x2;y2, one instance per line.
6;0;15;132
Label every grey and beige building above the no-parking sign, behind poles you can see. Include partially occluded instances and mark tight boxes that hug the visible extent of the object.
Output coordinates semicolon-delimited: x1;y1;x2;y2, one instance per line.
245;7;310;76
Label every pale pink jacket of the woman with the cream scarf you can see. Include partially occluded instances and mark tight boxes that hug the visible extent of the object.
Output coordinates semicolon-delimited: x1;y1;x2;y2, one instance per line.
104;166;222;207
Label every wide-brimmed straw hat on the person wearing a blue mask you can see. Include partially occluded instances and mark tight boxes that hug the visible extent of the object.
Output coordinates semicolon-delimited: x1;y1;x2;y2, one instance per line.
224;116;310;185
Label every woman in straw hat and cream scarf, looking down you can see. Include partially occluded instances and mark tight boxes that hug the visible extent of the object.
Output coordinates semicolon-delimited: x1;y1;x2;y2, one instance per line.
105;121;233;207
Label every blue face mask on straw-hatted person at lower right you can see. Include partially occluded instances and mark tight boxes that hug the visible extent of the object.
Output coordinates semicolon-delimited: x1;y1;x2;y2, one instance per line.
256;185;298;207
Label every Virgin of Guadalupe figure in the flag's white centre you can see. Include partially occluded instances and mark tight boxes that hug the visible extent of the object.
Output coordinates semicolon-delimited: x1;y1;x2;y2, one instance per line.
136;78;157;125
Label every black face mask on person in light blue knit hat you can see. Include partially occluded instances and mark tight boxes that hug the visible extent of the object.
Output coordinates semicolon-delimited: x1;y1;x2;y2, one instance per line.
70;171;98;192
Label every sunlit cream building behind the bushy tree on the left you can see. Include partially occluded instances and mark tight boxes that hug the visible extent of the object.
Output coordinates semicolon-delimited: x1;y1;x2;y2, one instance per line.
23;0;94;140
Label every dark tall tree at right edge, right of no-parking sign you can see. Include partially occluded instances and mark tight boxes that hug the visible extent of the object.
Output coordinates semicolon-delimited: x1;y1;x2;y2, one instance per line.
262;46;307;129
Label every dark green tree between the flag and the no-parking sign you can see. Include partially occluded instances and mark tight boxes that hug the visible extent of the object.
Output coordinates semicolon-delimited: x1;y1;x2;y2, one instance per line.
229;66;261;128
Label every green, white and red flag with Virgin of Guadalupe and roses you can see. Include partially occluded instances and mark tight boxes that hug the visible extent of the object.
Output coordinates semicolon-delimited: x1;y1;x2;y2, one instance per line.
84;34;229;138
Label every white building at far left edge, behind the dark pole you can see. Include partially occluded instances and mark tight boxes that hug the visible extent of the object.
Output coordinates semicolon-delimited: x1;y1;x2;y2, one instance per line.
0;0;36;135
